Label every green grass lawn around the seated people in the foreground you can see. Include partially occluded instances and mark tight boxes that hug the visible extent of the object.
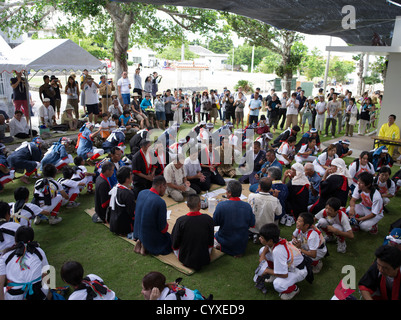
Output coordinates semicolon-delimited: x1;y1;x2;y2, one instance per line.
0;115;401;300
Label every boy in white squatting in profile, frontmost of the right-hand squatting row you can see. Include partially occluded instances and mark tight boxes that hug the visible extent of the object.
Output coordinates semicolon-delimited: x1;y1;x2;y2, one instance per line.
253;223;313;300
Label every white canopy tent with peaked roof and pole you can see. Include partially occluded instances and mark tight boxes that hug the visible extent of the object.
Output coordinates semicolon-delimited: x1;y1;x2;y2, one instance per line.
0;39;108;138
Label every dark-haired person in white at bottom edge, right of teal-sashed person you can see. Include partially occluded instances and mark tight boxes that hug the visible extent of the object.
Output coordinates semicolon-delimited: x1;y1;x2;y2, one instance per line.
60;261;118;300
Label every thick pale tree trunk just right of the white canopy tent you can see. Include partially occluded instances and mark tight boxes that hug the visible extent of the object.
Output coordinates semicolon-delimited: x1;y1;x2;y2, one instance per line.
105;2;134;83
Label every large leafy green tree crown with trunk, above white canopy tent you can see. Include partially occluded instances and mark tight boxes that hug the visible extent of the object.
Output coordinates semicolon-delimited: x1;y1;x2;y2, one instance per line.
0;0;219;78
